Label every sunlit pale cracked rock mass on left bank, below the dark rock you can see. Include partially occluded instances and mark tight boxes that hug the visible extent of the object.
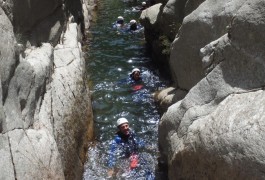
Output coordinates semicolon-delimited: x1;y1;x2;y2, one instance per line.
0;23;93;179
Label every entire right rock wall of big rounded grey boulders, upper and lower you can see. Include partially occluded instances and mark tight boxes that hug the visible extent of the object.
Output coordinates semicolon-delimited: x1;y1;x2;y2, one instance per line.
153;0;265;179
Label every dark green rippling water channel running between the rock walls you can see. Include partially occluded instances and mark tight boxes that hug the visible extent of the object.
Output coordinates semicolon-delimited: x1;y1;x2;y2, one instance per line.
83;0;168;180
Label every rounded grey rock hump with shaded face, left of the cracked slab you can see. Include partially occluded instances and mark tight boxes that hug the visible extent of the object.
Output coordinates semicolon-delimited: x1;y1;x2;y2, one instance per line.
3;44;53;132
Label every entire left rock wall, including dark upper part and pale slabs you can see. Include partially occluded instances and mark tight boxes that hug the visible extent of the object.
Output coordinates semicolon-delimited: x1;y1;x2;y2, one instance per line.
0;0;95;179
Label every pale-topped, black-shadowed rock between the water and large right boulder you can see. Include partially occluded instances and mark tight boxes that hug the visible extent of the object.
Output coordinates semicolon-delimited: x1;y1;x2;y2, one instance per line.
140;0;204;77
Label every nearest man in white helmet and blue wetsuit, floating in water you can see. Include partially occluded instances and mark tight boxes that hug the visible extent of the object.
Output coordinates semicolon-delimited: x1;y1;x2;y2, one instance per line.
108;117;143;177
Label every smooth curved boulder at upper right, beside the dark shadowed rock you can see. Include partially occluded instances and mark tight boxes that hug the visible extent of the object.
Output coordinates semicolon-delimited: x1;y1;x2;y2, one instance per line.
169;0;244;90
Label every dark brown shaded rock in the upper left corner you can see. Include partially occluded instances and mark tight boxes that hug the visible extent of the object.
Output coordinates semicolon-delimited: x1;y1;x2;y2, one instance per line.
0;0;66;47
